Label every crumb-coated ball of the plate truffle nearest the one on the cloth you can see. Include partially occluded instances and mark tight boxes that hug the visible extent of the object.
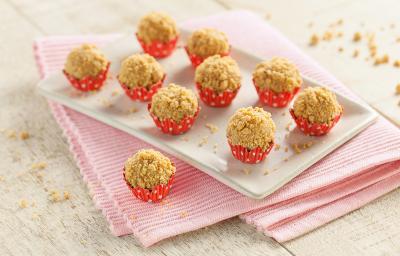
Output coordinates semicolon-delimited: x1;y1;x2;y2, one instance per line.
150;84;198;122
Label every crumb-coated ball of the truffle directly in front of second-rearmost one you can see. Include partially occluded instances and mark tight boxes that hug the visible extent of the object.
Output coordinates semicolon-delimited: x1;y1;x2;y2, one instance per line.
195;55;241;93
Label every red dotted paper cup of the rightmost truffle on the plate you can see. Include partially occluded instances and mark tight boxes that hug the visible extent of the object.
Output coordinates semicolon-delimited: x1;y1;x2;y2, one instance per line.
290;109;343;136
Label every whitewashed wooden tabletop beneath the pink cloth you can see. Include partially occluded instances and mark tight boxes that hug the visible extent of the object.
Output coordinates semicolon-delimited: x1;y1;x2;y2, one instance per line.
0;0;400;256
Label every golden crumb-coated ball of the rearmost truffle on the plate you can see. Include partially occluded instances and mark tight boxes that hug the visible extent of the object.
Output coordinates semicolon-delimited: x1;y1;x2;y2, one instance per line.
137;12;179;44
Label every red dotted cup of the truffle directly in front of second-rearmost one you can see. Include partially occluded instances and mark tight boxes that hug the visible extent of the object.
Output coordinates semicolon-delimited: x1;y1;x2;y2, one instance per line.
196;83;240;107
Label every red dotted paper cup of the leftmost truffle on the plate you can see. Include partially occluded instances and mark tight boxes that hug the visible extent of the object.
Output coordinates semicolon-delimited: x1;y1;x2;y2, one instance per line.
63;63;110;92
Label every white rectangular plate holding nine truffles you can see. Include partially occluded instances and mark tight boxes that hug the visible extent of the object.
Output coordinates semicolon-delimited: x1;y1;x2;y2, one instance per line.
38;31;377;199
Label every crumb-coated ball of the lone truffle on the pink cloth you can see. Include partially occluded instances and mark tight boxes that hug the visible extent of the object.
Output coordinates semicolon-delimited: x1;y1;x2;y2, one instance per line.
124;149;175;189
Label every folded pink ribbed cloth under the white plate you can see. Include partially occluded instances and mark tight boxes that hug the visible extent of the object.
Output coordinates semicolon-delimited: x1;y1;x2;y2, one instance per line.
35;11;400;246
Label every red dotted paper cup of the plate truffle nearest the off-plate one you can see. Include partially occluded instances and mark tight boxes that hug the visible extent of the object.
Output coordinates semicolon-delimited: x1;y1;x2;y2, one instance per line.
147;103;200;135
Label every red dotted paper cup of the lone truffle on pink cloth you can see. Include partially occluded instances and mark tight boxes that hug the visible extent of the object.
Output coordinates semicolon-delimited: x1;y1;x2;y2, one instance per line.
123;173;174;203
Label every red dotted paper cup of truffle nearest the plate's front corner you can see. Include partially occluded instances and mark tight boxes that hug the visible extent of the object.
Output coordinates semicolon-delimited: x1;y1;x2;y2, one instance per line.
228;141;274;164
